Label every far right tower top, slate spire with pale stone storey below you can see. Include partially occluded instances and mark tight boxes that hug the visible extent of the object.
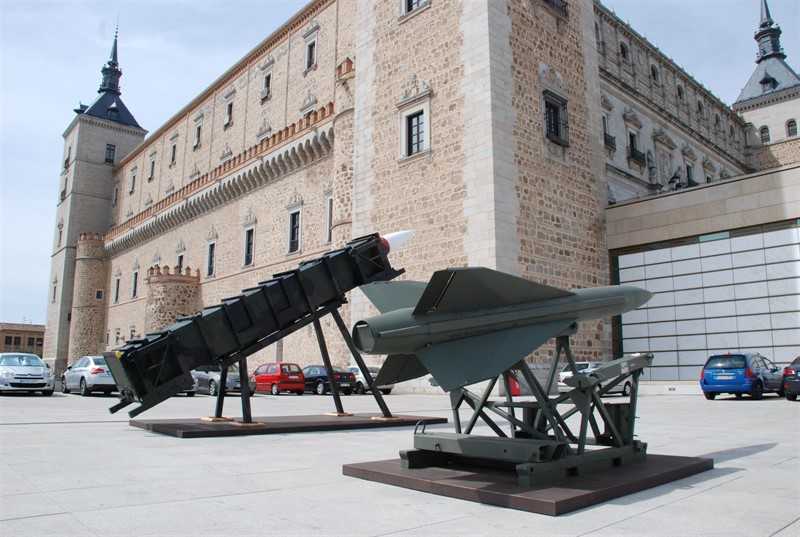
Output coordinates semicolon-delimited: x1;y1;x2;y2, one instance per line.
732;0;800;146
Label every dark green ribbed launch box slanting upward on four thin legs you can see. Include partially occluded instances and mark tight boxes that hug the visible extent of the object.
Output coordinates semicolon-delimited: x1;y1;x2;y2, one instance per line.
105;233;404;422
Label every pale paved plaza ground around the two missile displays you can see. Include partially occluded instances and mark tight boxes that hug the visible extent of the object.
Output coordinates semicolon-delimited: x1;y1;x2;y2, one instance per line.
0;386;800;537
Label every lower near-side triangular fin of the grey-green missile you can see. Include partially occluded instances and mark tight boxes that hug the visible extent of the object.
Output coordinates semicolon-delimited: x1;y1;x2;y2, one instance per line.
417;320;574;392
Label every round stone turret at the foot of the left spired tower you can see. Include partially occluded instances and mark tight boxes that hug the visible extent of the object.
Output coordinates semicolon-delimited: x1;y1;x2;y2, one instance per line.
68;233;108;358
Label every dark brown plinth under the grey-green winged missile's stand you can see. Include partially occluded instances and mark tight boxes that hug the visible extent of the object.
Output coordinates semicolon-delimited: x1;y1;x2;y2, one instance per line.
342;455;714;516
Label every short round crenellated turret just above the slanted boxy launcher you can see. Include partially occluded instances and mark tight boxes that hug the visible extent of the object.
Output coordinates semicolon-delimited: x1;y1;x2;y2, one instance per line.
144;265;202;333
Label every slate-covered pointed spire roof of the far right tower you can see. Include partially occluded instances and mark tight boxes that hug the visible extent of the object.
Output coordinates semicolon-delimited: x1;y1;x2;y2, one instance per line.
734;0;800;109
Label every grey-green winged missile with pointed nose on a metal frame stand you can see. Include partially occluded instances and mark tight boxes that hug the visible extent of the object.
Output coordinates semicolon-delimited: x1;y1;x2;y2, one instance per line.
353;267;652;391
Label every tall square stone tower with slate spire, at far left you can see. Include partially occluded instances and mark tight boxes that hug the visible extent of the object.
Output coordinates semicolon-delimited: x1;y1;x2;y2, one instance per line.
43;29;147;372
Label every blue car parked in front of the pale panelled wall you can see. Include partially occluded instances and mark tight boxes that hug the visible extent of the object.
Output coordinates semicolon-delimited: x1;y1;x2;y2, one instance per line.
700;352;783;400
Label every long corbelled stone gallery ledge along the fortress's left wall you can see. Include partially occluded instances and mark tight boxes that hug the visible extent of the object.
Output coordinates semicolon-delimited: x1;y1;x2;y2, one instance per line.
105;107;334;254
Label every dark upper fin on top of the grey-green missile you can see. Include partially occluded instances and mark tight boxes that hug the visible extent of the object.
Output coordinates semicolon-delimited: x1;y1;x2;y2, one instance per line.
414;267;574;315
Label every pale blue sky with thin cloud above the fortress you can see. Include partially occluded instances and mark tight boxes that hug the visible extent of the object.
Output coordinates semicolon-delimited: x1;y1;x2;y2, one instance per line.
0;0;800;323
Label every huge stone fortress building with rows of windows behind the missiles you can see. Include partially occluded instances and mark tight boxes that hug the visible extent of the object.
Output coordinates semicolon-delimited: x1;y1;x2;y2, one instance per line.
45;0;800;386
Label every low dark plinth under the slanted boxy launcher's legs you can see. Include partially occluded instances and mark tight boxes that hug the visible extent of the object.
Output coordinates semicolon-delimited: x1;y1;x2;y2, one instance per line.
129;414;447;438
